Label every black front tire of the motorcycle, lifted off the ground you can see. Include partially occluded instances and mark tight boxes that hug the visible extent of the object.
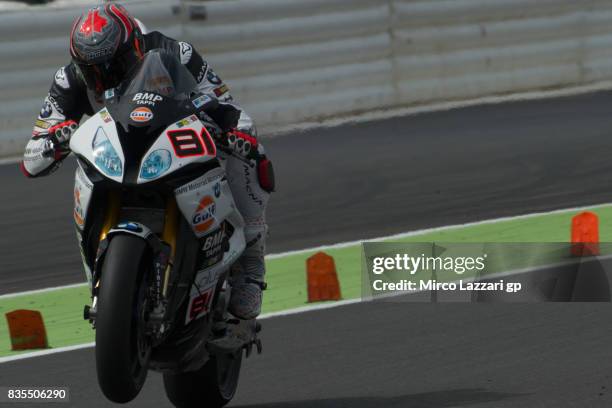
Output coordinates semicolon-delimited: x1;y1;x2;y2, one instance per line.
96;235;150;403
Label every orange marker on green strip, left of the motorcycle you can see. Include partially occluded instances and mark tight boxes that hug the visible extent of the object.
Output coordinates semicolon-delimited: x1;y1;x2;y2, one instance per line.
6;309;49;350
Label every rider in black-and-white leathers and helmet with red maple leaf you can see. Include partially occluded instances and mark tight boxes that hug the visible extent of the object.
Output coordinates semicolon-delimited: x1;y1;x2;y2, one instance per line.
21;3;274;319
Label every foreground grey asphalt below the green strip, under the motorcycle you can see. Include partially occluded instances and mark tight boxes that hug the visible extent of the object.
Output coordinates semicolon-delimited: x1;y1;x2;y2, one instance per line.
0;303;612;408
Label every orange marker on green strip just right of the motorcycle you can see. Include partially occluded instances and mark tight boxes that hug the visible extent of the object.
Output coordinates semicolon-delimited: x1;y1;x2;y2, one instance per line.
306;252;342;302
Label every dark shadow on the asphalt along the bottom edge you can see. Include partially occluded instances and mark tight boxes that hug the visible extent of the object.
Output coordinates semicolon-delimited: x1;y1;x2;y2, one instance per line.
232;388;526;408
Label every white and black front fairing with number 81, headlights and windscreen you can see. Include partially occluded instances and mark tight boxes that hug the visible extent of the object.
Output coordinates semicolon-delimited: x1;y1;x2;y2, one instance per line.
71;51;216;184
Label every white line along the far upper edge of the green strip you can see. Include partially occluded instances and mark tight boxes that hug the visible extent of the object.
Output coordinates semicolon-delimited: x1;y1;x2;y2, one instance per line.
0;203;612;300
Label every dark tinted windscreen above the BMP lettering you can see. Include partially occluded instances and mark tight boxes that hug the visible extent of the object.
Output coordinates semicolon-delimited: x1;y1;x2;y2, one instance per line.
119;50;197;99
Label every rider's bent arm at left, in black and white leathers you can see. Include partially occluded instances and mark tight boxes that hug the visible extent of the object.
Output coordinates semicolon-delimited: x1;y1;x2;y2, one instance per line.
21;64;88;177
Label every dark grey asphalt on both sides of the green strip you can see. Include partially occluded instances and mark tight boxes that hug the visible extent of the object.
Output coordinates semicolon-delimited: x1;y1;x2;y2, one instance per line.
0;93;612;408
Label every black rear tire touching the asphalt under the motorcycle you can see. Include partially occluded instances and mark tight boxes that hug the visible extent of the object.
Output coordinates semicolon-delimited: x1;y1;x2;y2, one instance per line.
164;350;242;408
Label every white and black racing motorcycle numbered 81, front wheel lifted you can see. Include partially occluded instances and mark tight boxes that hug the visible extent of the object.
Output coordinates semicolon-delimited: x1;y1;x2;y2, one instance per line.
70;51;261;408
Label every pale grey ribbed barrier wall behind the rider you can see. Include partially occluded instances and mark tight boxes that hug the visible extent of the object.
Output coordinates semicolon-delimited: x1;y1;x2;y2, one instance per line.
0;0;612;155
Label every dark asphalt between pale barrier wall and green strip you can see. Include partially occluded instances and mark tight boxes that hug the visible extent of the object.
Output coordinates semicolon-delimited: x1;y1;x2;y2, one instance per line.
0;92;612;294
